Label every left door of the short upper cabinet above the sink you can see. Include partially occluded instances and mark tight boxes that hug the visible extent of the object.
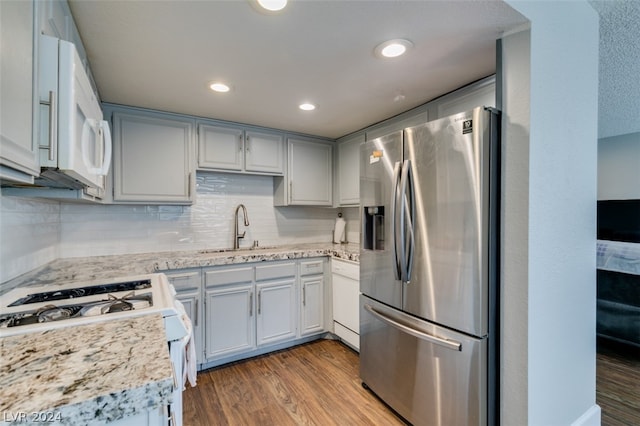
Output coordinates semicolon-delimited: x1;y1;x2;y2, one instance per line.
198;124;244;171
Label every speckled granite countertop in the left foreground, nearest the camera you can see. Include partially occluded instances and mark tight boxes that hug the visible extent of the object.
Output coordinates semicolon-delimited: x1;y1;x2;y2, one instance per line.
0;314;173;425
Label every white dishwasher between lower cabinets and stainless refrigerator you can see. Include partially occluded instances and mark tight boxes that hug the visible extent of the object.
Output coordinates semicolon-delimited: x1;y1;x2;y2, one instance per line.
331;259;360;349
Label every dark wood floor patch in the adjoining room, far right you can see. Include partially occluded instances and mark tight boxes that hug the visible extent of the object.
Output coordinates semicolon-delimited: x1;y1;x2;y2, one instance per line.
596;340;640;426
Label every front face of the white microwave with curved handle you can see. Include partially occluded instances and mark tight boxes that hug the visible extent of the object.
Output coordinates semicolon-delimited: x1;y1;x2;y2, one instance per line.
58;40;111;189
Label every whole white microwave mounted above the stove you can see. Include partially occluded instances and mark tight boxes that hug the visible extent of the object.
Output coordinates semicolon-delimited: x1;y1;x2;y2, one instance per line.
38;35;112;196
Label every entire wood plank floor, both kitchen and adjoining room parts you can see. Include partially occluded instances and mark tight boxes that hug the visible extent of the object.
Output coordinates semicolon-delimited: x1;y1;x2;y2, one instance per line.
184;340;640;426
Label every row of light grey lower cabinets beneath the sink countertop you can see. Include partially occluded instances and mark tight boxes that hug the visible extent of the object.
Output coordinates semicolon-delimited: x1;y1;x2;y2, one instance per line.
164;258;330;368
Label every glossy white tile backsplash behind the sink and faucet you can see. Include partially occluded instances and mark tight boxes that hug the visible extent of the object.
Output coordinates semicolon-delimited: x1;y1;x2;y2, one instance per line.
0;172;359;282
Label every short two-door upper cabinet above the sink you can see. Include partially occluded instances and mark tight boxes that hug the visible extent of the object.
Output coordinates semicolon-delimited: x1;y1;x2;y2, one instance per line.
198;122;285;175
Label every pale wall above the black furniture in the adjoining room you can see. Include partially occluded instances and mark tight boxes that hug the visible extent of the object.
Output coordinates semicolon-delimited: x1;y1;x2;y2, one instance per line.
598;131;640;200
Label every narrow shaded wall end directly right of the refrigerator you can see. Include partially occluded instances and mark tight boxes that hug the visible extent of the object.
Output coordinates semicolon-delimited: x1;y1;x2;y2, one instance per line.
500;25;531;425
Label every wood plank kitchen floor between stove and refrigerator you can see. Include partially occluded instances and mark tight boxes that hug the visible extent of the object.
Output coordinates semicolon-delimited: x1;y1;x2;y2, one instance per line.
183;340;404;426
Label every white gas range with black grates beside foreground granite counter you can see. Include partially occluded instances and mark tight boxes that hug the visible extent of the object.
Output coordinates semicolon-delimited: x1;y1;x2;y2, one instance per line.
0;274;194;426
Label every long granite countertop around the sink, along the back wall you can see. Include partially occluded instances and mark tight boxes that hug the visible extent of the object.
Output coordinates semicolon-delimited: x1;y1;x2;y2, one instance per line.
0;243;360;294
